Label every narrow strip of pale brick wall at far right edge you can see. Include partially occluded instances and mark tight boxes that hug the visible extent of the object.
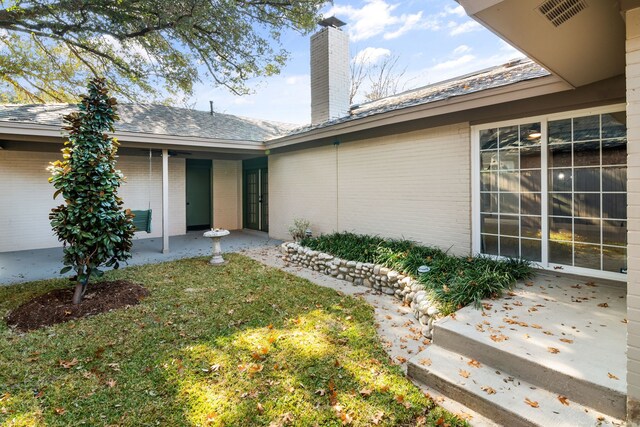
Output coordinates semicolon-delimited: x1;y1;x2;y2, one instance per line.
626;8;640;426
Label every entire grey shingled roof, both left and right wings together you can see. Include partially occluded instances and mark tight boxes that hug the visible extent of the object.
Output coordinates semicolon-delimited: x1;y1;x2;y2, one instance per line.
0;59;550;142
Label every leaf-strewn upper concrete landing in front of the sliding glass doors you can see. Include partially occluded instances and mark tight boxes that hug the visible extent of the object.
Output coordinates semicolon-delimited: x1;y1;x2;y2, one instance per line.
440;272;627;400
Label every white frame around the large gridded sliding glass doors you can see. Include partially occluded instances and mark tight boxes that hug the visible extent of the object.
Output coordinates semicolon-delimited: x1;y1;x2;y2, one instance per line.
470;104;628;282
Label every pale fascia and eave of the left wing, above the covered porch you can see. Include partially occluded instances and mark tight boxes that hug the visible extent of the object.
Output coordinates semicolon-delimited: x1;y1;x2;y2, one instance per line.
0;122;265;154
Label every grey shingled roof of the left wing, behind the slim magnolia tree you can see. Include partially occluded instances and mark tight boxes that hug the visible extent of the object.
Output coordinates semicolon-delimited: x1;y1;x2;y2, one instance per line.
0;104;295;142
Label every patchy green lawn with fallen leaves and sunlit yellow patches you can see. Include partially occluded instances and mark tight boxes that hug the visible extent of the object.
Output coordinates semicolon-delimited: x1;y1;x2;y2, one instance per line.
0;255;464;426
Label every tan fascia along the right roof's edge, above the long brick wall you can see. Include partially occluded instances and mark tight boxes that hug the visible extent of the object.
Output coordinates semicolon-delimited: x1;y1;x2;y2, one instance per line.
266;75;571;149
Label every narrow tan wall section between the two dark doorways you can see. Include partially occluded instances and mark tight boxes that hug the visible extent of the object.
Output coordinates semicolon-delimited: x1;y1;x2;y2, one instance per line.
213;160;242;230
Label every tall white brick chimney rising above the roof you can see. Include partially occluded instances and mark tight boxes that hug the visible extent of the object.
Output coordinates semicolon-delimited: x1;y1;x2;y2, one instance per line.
311;17;351;124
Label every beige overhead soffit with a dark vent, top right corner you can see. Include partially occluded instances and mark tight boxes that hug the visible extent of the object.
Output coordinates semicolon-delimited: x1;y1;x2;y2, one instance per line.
457;0;636;87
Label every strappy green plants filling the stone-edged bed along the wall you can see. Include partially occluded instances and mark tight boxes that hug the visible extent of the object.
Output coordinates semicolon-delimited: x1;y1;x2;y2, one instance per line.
300;233;533;314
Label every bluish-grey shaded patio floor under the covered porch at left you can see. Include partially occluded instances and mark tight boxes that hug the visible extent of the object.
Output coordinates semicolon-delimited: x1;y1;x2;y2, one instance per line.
0;230;281;286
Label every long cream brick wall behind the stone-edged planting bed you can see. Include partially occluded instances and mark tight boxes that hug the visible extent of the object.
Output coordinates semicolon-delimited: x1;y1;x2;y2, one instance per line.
269;123;471;254
